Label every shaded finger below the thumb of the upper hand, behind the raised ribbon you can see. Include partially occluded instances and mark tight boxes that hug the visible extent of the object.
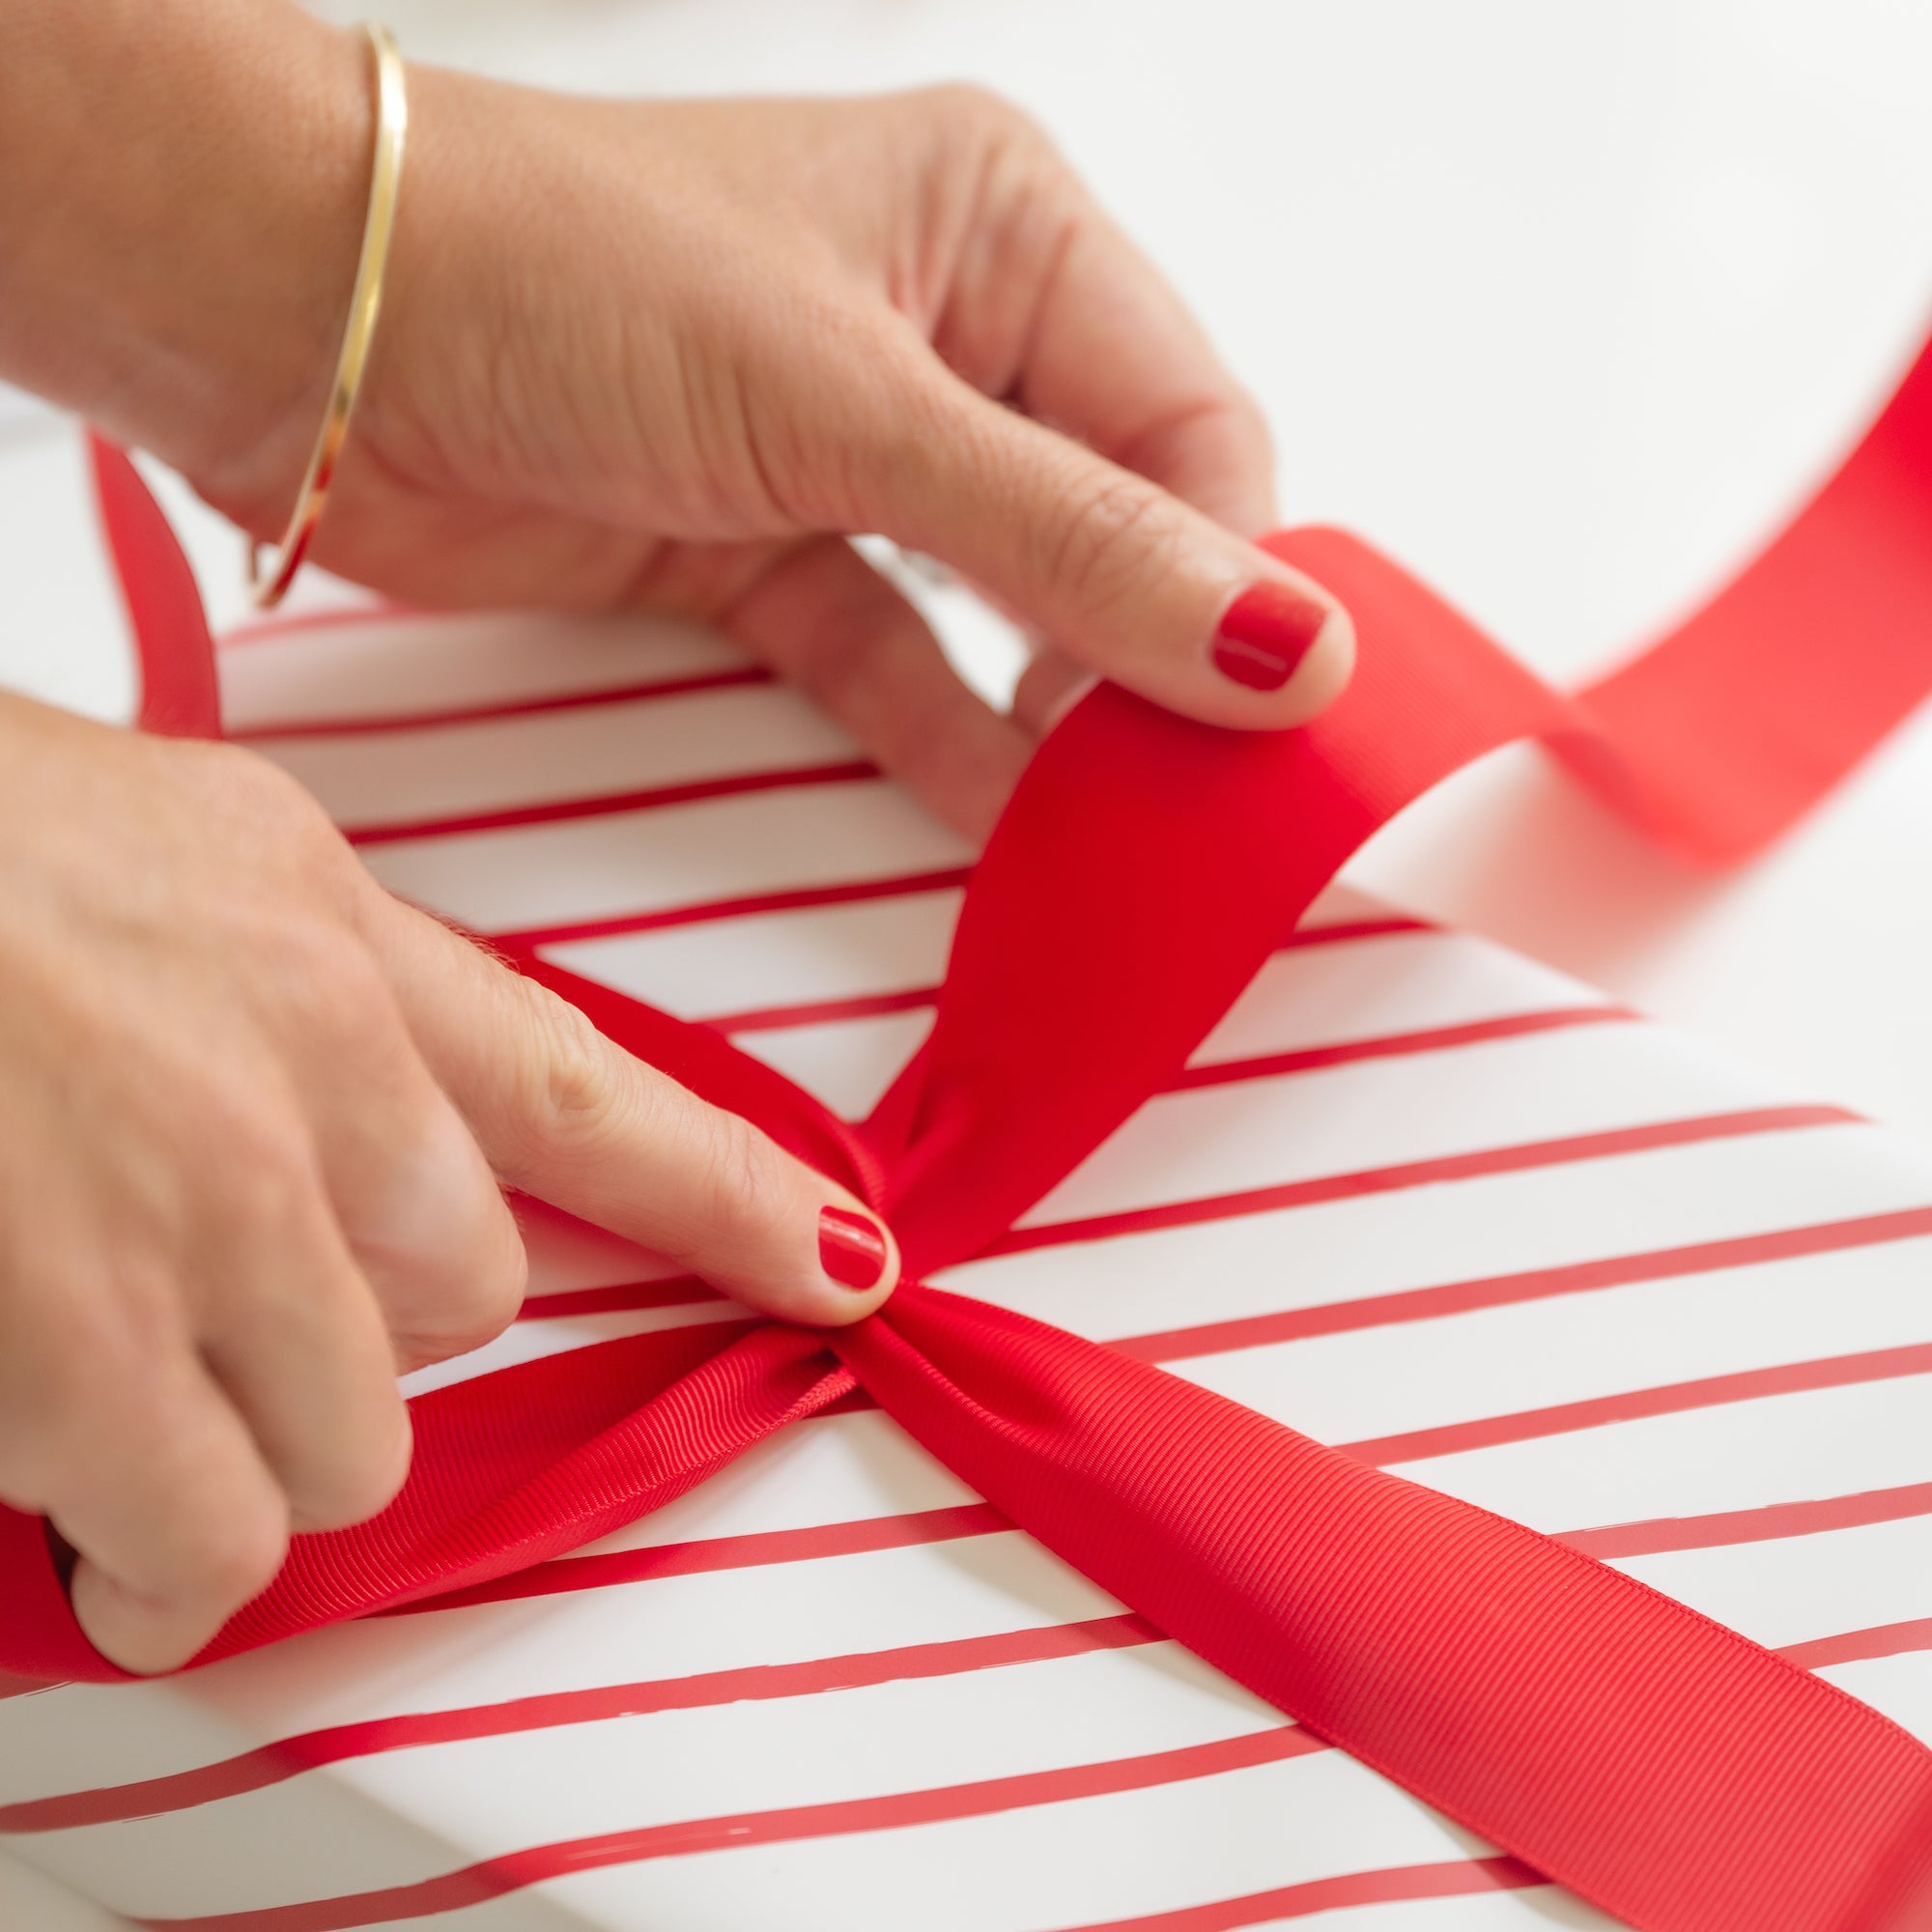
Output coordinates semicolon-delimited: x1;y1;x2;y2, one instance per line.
719;537;1032;840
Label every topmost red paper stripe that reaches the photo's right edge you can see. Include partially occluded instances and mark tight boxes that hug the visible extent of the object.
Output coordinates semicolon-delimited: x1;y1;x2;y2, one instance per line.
1109;1208;1932;1362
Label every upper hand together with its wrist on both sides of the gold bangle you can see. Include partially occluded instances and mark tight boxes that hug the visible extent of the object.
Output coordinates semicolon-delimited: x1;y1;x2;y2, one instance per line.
0;0;1352;833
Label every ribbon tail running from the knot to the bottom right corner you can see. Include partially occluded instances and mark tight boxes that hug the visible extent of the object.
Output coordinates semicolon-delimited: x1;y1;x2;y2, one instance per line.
833;1289;1932;1932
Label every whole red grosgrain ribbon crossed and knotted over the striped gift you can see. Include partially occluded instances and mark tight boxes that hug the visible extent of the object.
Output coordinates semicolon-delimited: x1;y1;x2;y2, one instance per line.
11;354;1932;1932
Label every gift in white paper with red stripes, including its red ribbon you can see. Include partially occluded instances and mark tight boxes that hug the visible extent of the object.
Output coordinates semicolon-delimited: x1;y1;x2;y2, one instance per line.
0;348;1932;1932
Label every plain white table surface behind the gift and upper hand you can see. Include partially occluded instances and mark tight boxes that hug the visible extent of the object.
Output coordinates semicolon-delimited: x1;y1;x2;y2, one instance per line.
0;0;1932;1932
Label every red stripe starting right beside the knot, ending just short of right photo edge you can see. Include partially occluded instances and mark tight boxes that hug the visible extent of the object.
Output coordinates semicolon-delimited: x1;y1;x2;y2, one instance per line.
976;1105;1864;1260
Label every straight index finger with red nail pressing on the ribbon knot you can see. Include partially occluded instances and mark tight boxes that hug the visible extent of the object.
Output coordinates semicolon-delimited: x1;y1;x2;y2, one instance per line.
365;885;898;1325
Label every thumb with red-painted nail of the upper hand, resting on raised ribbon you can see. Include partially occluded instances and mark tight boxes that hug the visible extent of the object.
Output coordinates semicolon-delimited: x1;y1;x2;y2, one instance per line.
856;371;1354;730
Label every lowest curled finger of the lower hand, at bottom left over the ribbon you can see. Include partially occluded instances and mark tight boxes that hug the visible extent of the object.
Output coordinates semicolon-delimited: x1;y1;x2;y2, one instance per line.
10;1335;288;1673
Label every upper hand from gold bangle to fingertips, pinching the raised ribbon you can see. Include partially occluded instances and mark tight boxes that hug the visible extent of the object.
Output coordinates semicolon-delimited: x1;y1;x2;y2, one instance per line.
294;70;1350;833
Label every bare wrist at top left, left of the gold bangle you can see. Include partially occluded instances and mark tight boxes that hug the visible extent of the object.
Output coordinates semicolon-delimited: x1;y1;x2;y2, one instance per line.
0;0;373;520
